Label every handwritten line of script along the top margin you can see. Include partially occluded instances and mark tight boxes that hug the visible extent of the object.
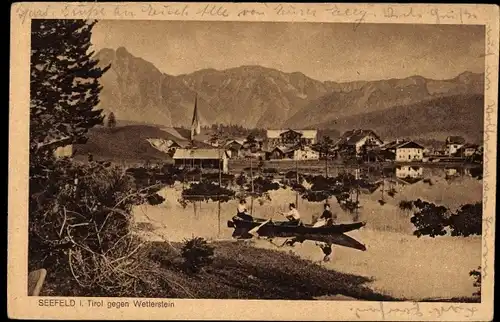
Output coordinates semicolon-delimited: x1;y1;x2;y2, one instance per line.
16;2;484;29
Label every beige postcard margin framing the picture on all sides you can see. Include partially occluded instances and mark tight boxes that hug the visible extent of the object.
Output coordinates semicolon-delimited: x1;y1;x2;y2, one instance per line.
7;2;499;321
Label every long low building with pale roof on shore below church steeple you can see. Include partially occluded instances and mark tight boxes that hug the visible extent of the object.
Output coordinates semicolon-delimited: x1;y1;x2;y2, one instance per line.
173;148;229;173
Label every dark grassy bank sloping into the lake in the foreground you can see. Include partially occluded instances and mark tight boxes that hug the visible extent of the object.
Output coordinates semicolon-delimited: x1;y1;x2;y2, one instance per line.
42;242;396;301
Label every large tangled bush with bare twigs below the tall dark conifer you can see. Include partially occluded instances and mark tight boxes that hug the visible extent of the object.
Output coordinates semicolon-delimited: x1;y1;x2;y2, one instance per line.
28;159;161;295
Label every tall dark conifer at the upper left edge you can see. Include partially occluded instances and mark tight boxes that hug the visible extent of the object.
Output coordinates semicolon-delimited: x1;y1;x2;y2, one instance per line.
30;19;110;160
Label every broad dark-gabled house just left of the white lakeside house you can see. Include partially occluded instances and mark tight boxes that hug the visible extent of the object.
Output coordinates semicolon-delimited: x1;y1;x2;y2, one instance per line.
335;129;384;155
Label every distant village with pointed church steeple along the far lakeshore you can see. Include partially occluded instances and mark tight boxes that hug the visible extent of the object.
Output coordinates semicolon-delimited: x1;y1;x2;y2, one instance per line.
56;101;483;177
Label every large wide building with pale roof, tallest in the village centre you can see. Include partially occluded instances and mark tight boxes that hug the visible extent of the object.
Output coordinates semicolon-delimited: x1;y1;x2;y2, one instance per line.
266;129;318;150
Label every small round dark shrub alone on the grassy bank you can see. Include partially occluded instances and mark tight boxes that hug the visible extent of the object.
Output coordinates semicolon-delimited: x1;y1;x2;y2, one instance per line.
181;237;214;273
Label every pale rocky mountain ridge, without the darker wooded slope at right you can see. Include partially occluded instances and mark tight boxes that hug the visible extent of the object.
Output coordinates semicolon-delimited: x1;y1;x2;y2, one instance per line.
94;47;484;140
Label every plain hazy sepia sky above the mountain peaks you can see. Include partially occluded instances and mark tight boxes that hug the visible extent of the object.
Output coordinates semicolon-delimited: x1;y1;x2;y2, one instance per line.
92;20;485;82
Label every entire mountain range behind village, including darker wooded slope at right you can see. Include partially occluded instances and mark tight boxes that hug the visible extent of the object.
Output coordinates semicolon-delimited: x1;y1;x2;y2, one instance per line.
95;47;484;141
